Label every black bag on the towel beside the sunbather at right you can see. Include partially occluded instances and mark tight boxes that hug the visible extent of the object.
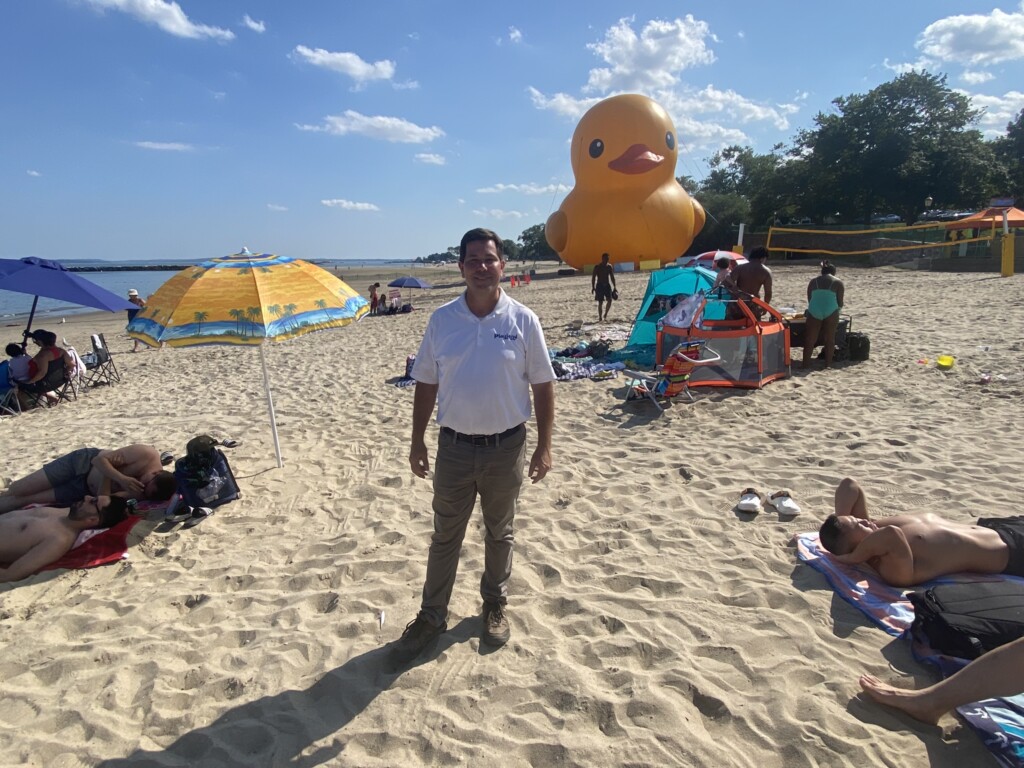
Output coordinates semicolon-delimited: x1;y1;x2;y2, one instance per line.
907;581;1024;659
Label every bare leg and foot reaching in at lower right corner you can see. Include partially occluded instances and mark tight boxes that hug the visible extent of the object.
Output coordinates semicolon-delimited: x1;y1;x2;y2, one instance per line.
860;638;1024;725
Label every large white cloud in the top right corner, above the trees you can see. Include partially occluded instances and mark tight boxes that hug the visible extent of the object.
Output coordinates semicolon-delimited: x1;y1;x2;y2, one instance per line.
914;4;1024;67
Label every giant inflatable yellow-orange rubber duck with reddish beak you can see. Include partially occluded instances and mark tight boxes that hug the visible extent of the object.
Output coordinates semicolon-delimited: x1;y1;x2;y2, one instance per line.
545;93;705;269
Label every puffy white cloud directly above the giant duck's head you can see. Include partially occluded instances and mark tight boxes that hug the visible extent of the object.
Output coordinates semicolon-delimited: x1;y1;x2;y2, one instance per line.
584;14;716;93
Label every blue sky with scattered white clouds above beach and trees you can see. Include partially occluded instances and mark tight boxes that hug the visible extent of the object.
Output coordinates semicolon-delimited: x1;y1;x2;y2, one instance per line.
0;0;1024;260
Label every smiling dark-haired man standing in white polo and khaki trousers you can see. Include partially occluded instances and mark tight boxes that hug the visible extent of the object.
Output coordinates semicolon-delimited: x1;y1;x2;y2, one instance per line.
389;229;555;665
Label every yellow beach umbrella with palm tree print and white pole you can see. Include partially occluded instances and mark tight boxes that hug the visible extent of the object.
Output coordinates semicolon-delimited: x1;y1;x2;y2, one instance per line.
128;248;370;467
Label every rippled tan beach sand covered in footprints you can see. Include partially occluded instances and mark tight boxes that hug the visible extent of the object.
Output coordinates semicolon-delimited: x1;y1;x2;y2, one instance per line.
0;265;1024;768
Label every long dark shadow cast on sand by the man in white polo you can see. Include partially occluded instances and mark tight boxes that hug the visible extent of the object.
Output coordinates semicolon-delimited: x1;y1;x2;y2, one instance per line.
98;616;479;768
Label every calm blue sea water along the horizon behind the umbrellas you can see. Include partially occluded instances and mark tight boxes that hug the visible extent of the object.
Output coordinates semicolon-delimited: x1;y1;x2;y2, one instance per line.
0;260;412;319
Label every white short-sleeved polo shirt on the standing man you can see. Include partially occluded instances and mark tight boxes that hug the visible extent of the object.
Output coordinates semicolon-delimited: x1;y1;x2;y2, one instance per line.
413;291;555;434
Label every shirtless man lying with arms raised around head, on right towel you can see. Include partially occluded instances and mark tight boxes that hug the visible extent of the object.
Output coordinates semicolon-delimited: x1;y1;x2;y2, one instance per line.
818;477;1024;587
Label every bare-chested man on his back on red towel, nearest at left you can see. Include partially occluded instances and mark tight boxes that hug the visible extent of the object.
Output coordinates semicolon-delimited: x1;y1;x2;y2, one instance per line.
0;496;128;583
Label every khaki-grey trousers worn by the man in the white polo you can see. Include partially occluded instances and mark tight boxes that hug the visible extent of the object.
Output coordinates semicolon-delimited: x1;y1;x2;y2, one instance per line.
421;428;526;625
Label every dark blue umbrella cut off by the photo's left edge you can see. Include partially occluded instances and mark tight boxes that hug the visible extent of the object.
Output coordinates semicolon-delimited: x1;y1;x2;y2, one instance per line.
0;256;135;333
